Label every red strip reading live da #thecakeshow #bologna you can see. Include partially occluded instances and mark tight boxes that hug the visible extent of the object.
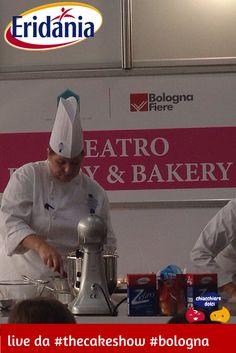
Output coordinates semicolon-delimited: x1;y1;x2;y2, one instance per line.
0;324;236;353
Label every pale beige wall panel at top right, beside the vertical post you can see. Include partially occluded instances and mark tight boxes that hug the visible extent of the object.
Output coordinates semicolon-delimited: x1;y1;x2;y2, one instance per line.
133;0;236;67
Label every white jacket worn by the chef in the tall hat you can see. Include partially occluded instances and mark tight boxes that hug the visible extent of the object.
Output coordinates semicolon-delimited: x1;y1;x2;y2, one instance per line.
0;161;116;280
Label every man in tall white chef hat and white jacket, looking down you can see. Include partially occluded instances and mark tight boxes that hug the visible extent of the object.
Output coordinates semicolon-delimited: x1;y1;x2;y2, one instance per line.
0;90;116;280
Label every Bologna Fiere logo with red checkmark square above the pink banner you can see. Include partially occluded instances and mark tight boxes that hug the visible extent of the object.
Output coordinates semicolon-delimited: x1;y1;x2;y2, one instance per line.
130;92;193;112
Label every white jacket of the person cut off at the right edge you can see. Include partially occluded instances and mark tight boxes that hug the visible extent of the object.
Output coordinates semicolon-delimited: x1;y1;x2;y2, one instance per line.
191;199;236;286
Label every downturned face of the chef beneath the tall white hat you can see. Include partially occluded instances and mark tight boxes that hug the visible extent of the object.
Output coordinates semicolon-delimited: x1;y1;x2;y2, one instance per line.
48;149;84;182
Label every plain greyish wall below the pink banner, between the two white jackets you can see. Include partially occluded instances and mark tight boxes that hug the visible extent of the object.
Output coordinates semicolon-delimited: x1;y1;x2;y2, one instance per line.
112;207;221;277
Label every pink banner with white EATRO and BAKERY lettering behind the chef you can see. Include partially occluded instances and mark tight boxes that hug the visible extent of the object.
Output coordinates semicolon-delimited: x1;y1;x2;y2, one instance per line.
0;127;236;192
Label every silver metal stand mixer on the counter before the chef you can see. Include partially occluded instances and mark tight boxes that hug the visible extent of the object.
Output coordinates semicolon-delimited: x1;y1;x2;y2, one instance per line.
69;214;116;315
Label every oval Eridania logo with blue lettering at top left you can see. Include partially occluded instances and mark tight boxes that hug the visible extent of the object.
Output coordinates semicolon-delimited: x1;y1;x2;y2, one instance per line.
5;2;102;50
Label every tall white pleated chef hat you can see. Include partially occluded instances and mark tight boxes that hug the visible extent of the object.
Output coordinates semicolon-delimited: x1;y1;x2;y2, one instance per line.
49;90;84;158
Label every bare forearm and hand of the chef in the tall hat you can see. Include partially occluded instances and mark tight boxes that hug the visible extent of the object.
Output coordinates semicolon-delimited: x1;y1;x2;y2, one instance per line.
22;234;66;277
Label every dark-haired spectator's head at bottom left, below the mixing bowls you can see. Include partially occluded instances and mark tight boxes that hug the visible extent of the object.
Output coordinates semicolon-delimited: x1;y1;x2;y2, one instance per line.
8;297;76;324
